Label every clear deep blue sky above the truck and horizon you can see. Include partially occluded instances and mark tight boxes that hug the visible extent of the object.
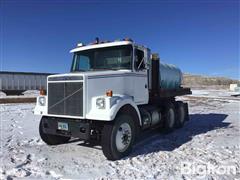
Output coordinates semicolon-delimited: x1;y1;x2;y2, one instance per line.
0;0;240;79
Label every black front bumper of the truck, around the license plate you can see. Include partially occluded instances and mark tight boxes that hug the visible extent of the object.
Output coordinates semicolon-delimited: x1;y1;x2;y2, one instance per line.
42;117;90;140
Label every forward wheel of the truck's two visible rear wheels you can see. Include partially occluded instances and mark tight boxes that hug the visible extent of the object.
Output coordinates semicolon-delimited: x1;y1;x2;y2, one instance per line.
164;102;176;133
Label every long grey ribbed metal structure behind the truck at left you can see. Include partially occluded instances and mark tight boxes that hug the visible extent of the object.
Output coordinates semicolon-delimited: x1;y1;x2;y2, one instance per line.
0;71;51;95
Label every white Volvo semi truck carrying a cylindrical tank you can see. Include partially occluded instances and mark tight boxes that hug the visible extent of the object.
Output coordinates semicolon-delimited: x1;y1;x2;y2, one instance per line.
34;39;191;160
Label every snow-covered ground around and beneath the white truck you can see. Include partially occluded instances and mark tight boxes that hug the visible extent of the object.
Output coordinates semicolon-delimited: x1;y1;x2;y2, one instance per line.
0;90;240;179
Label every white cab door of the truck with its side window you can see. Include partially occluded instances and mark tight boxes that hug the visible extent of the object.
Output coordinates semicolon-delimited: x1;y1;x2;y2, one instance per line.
133;47;149;104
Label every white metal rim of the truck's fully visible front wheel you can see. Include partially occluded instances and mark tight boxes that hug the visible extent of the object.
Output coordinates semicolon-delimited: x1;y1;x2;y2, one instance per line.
116;123;132;152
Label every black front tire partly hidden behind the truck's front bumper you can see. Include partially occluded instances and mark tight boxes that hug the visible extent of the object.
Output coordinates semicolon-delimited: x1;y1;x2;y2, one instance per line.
39;117;70;145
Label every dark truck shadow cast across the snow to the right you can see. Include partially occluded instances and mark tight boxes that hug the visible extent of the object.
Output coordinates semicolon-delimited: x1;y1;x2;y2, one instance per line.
130;113;230;157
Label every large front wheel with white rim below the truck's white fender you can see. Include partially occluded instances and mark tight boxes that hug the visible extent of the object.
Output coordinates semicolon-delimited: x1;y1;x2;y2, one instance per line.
102;114;135;160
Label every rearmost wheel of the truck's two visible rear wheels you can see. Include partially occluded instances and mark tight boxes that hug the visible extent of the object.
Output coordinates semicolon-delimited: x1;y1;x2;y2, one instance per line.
175;101;186;128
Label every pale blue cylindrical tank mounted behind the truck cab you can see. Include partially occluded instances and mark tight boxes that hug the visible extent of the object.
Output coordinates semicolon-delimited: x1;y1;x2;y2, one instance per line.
159;63;182;89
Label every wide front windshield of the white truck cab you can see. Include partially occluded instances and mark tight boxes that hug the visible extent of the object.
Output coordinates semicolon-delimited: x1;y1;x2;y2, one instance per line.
71;45;133;72
